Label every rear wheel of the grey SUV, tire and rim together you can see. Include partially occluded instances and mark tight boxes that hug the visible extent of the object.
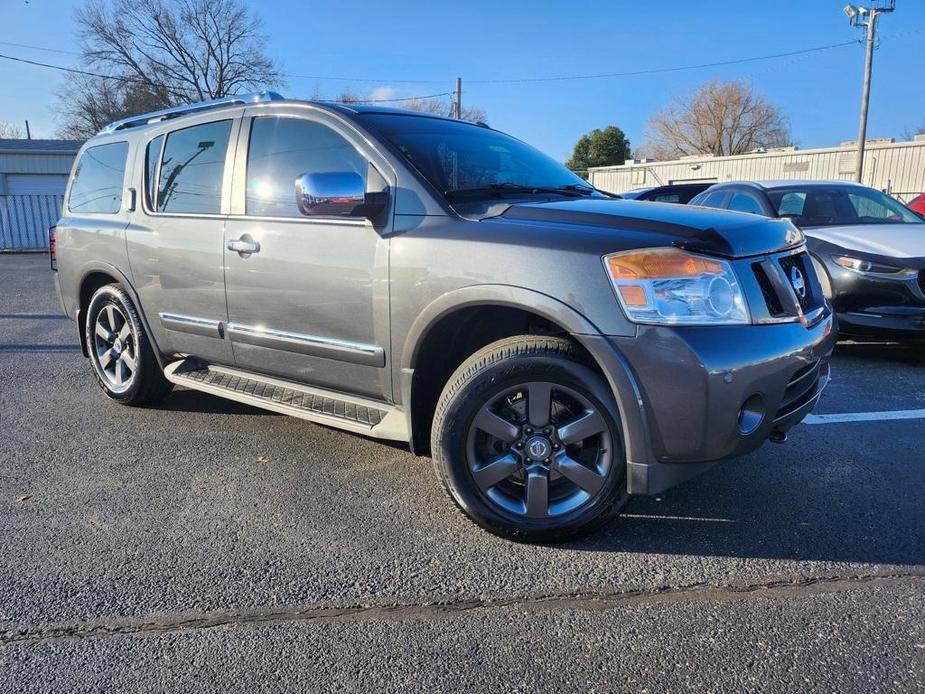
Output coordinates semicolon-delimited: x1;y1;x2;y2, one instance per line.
84;284;173;406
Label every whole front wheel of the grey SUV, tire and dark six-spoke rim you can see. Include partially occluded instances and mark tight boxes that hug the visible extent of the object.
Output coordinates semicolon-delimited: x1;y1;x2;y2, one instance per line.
431;335;627;543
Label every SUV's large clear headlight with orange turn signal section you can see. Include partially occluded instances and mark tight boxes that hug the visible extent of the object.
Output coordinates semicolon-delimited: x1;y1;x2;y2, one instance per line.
604;248;749;325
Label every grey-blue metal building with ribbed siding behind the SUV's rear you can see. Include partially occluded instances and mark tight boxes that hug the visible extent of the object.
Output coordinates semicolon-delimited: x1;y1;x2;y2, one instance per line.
0;140;83;251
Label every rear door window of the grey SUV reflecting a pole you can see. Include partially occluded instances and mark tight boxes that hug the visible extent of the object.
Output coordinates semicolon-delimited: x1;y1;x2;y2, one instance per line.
157;120;231;214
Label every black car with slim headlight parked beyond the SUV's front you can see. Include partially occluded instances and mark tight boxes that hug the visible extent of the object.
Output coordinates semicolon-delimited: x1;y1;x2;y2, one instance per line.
690;181;925;338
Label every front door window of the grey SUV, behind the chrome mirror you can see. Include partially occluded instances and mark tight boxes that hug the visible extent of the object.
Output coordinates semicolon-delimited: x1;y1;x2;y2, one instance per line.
245;117;369;217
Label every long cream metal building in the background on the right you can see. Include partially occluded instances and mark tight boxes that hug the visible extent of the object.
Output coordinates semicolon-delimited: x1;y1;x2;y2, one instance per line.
589;135;925;202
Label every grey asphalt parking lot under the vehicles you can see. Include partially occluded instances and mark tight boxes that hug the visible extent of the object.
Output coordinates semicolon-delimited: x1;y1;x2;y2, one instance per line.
0;255;925;692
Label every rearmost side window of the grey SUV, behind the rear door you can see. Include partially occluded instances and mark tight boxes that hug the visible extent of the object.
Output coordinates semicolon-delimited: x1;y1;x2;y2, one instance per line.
67;142;128;214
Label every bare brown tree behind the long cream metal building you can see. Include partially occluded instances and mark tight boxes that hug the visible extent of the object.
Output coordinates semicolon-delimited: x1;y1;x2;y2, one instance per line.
642;80;791;159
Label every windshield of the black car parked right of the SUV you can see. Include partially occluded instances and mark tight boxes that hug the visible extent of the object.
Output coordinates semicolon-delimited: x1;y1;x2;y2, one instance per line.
768;186;922;227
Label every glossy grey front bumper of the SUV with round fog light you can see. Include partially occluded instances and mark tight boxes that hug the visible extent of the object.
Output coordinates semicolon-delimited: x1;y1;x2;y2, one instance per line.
584;311;835;494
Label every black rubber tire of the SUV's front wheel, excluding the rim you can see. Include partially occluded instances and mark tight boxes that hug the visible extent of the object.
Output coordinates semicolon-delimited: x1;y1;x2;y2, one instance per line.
434;354;626;542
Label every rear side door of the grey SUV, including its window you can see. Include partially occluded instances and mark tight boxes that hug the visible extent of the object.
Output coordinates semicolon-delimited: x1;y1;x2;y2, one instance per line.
126;114;241;363
